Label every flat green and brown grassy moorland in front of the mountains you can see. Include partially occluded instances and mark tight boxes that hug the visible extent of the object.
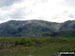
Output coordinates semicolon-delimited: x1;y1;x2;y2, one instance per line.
0;37;75;56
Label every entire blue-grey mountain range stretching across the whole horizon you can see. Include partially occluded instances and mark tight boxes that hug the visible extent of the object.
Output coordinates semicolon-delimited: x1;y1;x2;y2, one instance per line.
0;20;75;36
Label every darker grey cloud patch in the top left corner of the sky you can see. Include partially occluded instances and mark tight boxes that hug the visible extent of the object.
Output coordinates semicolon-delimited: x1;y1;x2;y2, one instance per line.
0;0;22;7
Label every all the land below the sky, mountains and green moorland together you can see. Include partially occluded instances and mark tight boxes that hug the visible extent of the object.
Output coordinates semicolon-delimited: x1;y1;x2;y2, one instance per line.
0;20;75;56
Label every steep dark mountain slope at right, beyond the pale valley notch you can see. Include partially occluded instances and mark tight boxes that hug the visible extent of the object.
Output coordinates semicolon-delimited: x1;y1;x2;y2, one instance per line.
52;20;75;37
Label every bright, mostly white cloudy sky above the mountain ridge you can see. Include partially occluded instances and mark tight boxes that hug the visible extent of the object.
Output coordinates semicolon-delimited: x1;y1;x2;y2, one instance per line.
0;0;75;23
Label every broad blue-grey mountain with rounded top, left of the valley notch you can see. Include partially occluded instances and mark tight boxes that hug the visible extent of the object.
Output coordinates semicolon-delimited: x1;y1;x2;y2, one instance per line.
0;20;59;36
